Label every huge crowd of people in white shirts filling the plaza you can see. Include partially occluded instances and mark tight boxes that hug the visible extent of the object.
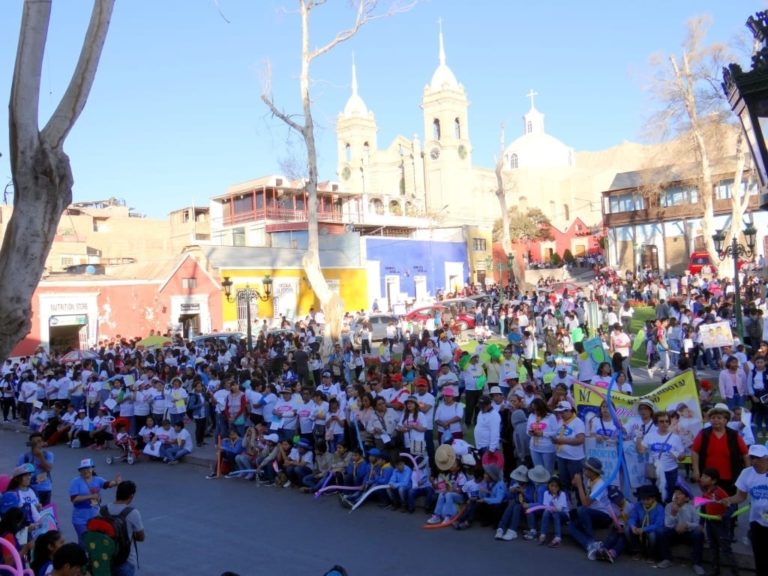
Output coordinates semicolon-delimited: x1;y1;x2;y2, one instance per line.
0;269;768;574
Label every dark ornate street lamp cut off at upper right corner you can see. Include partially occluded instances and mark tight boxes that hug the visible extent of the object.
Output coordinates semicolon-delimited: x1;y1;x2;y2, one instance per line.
722;10;768;210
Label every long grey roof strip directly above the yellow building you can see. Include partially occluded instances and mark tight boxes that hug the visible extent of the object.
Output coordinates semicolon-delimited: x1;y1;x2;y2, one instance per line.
200;243;362;270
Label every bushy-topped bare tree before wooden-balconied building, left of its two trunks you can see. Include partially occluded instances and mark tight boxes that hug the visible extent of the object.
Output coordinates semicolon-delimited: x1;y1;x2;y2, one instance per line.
653;17;744;278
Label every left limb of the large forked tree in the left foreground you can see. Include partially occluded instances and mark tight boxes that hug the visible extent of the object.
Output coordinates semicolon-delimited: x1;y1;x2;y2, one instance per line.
10;0;51;160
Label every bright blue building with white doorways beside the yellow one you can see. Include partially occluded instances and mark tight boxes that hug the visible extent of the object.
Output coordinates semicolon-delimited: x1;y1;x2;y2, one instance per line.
363;237;468;310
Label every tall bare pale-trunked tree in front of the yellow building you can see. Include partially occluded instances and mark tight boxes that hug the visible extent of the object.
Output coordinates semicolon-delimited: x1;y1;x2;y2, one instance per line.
261;0;415;357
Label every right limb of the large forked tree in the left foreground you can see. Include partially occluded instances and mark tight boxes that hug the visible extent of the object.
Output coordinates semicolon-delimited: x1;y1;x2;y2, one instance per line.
42;0;115;148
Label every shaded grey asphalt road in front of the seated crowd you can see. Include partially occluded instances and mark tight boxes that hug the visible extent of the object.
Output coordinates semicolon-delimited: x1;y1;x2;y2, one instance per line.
0;429;704;576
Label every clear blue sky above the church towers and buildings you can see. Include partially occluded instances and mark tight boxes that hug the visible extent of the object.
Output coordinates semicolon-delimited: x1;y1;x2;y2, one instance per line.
0;0;765;218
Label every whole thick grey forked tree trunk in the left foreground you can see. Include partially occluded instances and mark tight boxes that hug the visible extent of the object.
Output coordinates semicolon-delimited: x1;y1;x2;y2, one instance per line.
0;0;115;358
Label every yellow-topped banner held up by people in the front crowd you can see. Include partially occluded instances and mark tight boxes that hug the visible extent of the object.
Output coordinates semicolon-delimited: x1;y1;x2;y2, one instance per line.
573;370;702;488
